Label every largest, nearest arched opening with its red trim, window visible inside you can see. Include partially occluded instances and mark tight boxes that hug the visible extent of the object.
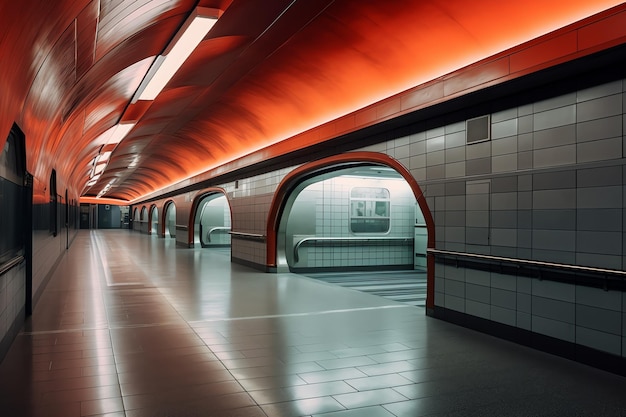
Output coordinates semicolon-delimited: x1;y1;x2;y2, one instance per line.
267;152;434;306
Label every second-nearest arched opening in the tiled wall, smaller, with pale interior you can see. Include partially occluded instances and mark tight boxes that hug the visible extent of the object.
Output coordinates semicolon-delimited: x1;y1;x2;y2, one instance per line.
192;189;231;248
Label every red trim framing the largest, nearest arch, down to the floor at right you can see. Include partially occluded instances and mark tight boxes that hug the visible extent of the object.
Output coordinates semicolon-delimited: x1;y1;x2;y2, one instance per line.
266;152;435;309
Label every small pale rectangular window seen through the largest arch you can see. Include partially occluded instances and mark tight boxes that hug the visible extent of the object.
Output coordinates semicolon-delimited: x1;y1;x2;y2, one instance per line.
350;187;390;233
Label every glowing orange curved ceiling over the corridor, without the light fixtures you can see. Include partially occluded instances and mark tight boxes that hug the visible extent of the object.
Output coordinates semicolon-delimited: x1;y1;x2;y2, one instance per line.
0;0;621;201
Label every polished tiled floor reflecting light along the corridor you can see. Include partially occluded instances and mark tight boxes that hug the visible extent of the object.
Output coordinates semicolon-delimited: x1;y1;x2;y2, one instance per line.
0;231;626;417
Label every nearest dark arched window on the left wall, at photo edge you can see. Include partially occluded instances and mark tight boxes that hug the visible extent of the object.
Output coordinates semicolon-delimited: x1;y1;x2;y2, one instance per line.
0;126;26;263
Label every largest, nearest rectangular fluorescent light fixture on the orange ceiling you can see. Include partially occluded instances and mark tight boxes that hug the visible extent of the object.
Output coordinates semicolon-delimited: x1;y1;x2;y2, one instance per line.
131;7;221;103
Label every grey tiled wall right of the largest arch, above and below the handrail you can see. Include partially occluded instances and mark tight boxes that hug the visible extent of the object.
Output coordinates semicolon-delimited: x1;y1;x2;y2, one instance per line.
409;81;626;356
